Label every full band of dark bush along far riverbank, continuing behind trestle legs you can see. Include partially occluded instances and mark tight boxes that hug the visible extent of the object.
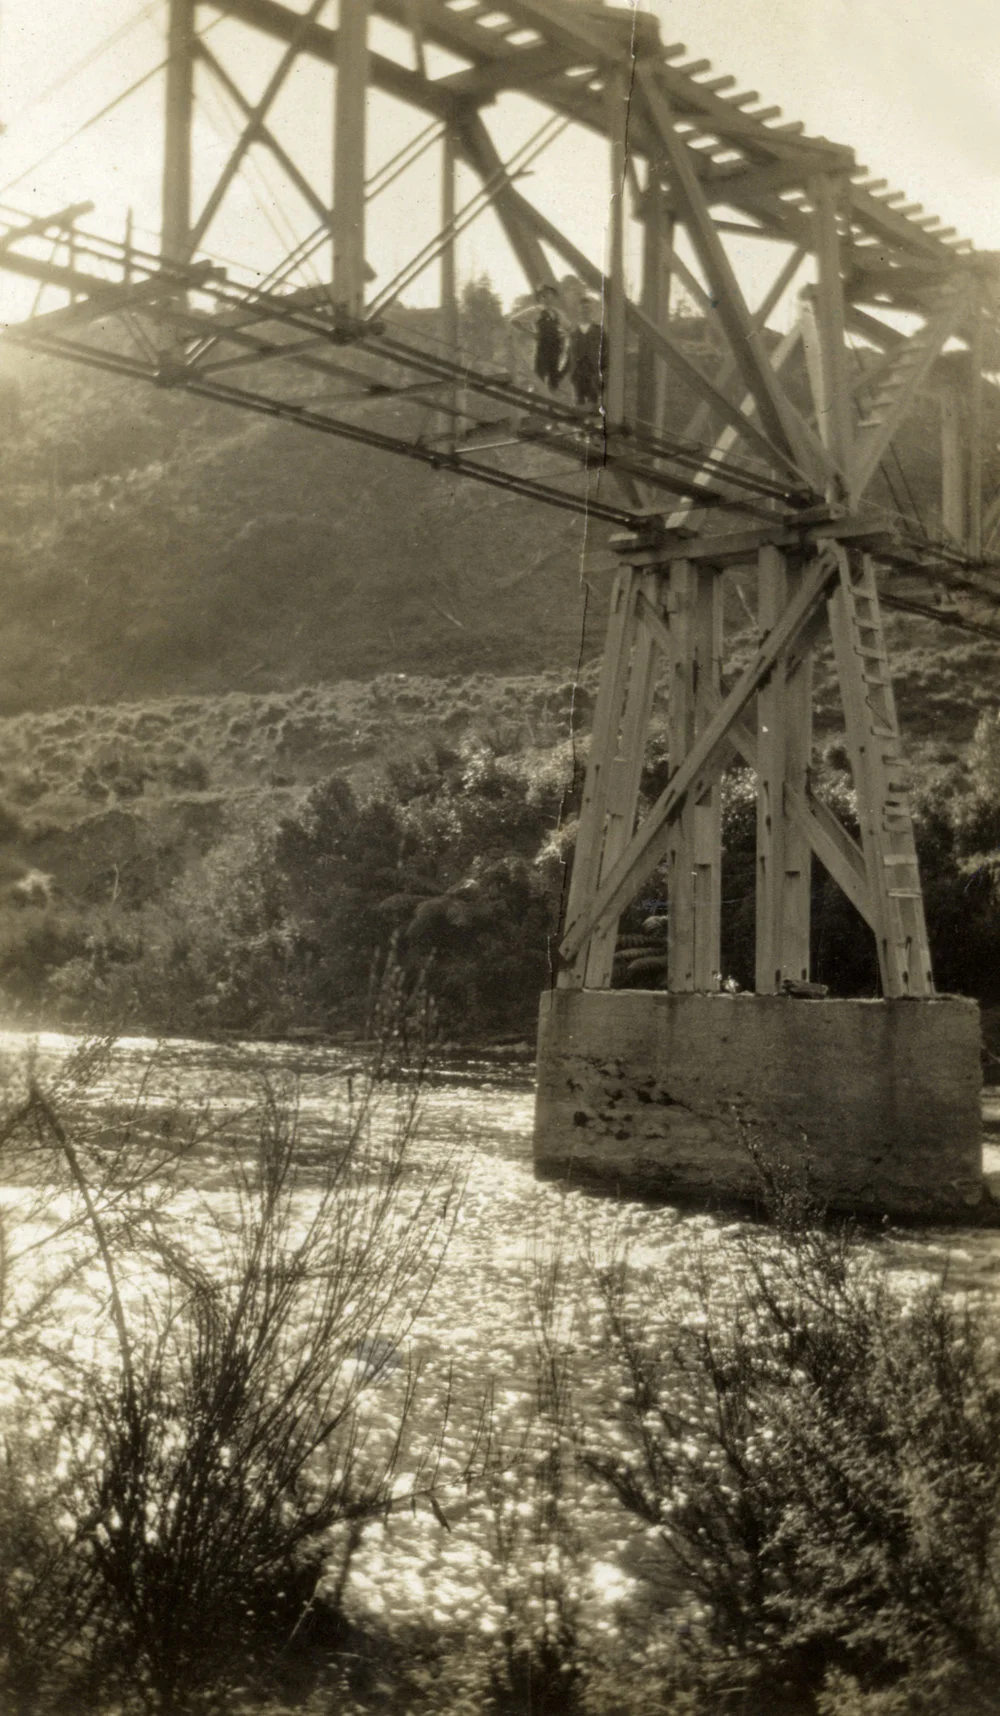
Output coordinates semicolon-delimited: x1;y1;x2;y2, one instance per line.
0;700;1000;1040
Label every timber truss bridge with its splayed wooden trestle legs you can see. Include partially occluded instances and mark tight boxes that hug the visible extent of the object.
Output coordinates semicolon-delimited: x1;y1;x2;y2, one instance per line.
0;0;1000;997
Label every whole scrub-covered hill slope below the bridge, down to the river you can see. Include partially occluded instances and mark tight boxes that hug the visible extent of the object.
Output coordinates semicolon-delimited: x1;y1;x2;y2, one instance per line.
0;292;1000;1038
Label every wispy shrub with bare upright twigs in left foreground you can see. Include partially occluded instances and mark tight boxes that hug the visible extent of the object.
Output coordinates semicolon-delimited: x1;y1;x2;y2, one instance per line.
0;995;456;1716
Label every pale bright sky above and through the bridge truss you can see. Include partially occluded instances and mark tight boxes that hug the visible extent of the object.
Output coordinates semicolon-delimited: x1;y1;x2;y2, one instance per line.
0;0;1000;319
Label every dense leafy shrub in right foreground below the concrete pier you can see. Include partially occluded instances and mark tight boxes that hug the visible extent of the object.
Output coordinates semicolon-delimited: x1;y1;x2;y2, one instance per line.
581;1199;1000;1716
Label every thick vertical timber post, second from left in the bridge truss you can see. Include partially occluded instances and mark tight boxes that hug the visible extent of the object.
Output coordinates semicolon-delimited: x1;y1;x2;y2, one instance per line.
333;0;369;316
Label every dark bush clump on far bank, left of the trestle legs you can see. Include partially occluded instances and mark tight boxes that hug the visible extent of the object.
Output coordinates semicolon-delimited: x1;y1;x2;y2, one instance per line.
66;743;557;1036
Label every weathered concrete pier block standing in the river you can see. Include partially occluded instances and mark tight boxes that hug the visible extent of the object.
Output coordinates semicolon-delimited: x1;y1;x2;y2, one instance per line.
535;988;988;1220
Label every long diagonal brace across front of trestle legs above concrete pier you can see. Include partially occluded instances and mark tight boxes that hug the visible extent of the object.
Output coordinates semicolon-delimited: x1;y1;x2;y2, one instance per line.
561;553;839;959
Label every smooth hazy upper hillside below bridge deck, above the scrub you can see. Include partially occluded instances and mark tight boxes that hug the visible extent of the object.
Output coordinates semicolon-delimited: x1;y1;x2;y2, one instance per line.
0;327;617;714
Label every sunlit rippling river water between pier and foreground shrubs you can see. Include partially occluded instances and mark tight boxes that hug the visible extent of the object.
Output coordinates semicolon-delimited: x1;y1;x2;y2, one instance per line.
0;1033;1000;1620
